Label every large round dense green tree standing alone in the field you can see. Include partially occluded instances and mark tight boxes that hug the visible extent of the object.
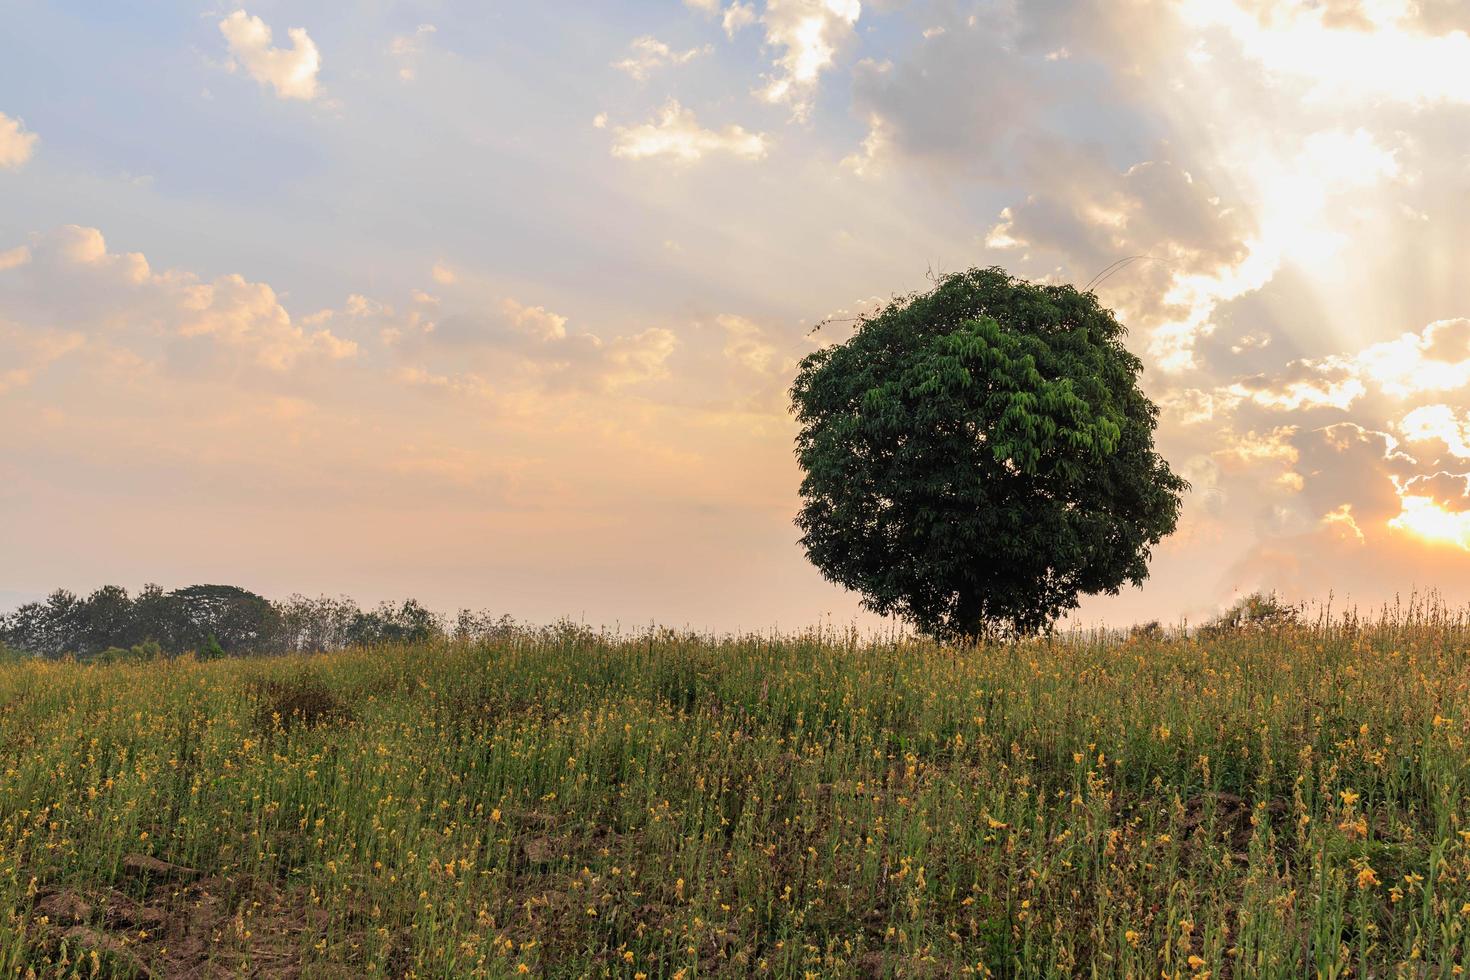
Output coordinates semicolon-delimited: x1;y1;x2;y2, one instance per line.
791;269;1189;639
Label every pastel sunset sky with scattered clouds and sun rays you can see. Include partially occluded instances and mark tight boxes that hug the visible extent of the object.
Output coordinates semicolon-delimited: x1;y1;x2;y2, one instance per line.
0;0;1470;630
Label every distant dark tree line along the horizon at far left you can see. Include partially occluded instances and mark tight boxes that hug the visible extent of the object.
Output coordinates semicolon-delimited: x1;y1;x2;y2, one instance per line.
0;585;516;660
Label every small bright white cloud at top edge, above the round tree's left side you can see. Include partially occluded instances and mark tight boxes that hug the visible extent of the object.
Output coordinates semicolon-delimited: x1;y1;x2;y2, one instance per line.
758;0;863;119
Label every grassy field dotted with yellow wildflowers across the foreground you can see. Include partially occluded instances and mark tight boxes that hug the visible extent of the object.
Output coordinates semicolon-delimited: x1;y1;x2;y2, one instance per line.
0;616;1470;980
